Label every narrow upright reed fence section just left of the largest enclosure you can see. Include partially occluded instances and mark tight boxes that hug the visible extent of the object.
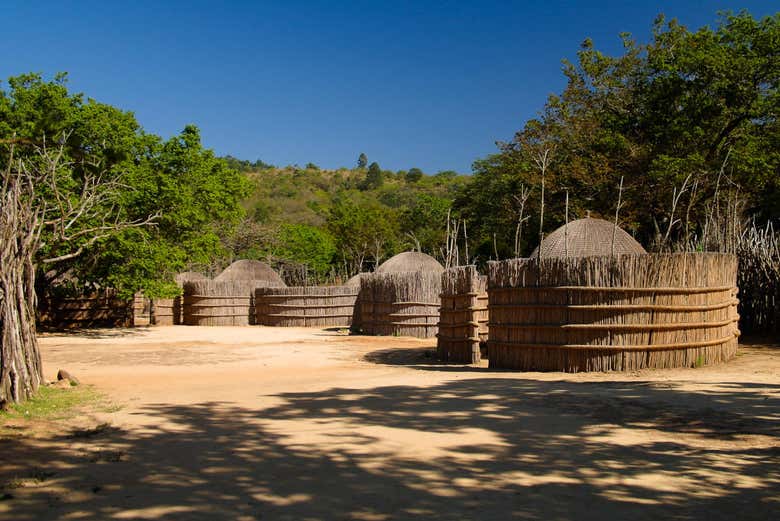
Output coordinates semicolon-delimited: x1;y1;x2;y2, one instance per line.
436;266;488;364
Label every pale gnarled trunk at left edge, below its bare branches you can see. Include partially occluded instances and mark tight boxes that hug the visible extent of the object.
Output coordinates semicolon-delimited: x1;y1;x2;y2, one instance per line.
0;258;43;403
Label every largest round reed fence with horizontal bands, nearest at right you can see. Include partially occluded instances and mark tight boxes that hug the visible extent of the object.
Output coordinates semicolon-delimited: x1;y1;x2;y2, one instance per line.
488;253;739;372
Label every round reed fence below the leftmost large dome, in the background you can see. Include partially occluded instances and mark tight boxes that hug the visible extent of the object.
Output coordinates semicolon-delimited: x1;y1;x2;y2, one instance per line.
184;280;267;326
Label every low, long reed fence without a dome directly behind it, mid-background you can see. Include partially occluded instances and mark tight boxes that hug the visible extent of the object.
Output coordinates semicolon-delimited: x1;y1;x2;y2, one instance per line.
255;285;359;327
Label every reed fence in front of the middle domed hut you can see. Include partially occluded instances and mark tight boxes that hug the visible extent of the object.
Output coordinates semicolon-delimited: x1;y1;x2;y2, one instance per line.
353;272;441;338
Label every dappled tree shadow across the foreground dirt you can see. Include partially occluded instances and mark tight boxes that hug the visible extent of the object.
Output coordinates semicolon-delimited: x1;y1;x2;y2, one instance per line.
0;377;780;521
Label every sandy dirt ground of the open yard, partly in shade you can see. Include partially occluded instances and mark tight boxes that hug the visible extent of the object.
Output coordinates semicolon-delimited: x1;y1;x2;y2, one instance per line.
0;326;780;521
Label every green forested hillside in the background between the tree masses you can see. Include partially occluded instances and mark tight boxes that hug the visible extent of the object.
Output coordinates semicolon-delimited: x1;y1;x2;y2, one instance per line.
216;158;470;280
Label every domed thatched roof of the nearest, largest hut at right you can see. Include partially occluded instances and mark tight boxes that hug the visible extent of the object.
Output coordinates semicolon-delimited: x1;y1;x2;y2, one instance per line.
531;217;647;259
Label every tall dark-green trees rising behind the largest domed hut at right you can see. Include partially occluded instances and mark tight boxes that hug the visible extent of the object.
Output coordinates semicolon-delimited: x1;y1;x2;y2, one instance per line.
457;12;780;251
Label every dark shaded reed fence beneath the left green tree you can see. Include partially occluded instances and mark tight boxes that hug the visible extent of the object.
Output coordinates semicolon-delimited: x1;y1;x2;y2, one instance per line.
40;290;136;329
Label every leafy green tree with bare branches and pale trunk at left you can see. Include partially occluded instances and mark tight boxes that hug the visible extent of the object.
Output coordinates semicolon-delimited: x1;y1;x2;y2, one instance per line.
0;74;248;402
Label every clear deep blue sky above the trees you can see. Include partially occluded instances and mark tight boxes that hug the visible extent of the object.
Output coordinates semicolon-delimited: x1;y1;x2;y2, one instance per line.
0;0;778;173
